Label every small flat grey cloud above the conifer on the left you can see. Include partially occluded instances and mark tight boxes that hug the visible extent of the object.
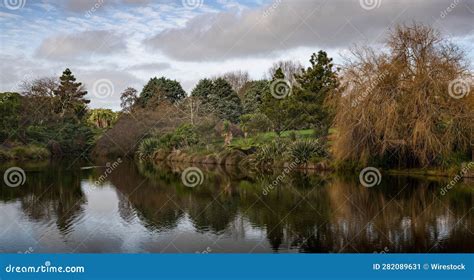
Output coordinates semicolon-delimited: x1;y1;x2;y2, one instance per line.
36;30;126;60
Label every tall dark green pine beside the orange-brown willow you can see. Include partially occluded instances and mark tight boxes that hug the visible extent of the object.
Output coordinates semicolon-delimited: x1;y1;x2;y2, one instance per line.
289;51;339;133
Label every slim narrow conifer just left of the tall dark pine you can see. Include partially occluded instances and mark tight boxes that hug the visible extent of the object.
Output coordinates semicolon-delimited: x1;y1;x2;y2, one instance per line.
262;68;291;137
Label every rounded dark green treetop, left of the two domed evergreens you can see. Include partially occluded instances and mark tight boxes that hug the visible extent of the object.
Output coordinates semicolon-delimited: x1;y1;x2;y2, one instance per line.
139;77;186;106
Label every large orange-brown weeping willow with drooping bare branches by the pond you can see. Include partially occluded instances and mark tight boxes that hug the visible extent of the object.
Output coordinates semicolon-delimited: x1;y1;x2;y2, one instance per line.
333;24;474;167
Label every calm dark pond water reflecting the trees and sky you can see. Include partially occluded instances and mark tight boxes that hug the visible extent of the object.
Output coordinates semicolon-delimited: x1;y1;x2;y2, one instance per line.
0;161;474;253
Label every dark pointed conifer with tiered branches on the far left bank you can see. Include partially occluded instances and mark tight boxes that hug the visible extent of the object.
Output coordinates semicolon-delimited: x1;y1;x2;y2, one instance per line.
54;68;90;119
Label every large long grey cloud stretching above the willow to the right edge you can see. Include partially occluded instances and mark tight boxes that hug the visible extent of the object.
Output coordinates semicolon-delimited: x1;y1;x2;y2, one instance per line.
144;0;474;61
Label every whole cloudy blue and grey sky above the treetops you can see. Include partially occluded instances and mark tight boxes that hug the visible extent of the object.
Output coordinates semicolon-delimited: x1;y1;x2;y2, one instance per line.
0;0;474;110
